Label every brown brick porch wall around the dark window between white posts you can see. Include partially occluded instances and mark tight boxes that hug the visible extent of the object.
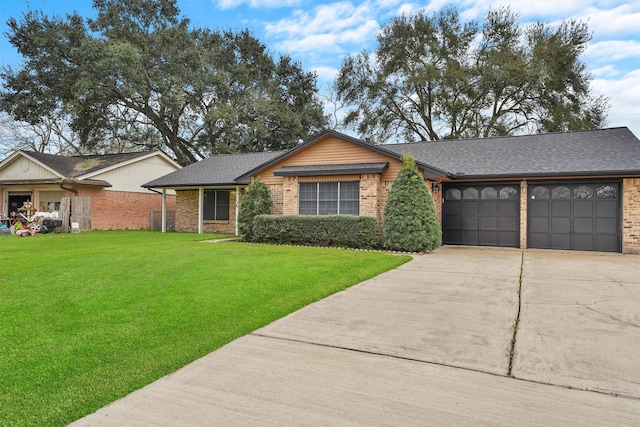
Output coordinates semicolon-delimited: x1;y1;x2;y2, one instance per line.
176;190;236;234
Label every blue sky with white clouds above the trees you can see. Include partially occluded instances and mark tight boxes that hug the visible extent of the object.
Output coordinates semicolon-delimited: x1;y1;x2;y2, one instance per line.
0;0;640;137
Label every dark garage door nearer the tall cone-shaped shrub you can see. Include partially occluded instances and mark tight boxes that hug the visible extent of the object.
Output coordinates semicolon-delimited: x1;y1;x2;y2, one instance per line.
442;184;520;247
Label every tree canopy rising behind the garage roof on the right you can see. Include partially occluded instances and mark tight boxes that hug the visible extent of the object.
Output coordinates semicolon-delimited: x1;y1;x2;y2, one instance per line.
336;7;608;143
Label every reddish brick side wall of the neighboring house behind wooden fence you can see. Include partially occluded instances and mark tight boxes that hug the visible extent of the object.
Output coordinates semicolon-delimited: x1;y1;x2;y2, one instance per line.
74;188;176;230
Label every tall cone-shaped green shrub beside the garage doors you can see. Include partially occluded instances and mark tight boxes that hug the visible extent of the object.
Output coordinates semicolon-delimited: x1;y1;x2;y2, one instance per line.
384;154;442;252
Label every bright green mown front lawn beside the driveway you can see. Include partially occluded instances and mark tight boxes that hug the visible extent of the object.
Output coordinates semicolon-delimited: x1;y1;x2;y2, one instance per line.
0;231;409;426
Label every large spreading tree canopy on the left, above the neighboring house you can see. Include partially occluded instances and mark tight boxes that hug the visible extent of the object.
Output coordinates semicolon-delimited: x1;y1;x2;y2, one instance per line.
0;0;327;164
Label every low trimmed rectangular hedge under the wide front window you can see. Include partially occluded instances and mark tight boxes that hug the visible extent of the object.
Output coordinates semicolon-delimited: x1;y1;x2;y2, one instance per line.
251;215;382;249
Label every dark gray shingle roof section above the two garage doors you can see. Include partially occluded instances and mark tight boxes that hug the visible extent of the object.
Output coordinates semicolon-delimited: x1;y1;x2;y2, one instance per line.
384;127;640;178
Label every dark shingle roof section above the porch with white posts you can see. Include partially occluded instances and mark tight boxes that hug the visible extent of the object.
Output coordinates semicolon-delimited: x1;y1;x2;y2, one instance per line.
143;151;284;188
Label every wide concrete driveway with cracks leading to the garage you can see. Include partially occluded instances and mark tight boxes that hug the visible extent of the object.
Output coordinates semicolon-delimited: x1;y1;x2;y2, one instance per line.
73;247;640;426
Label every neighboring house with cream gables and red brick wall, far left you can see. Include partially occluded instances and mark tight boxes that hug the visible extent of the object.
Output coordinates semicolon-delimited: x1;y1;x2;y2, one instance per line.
0;151;180;229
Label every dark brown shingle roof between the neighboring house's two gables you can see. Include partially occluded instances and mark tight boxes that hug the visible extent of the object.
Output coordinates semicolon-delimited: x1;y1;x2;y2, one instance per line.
23;151;149;178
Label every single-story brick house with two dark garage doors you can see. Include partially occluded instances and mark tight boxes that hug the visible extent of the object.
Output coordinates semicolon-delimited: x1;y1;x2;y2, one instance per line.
144;128;640;253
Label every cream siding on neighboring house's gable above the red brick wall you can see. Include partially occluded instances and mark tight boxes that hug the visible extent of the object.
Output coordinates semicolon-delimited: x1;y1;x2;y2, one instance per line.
91;156;177;193
